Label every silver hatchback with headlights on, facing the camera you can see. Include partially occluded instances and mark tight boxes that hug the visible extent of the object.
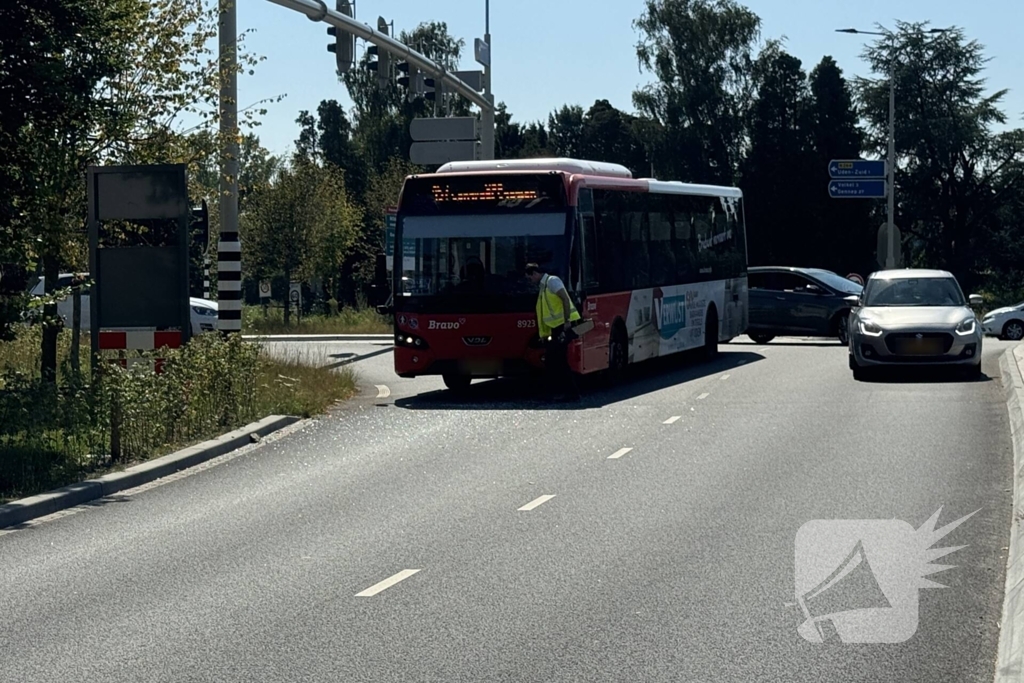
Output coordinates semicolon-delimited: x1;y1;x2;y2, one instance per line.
849;268;983;379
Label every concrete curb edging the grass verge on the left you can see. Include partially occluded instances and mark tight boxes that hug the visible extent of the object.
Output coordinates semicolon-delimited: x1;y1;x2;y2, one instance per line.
0;415;299;528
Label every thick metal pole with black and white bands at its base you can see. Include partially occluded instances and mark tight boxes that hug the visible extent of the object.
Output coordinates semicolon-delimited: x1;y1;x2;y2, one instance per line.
217;0;242;333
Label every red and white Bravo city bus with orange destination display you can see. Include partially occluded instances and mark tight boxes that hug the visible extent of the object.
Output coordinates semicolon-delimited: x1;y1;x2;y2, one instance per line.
390;159;748;389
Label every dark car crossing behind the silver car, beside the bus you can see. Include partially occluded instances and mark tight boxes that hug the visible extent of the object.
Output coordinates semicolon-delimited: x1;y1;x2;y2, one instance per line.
746;266;863;344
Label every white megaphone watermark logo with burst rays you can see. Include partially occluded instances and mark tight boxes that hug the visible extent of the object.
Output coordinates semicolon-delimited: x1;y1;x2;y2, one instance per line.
788;508;978;643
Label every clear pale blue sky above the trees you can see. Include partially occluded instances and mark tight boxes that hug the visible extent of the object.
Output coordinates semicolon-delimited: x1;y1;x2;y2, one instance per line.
238;0;1024;154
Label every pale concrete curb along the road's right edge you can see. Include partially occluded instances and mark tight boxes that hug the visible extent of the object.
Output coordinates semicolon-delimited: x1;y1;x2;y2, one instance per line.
995;345;1024;683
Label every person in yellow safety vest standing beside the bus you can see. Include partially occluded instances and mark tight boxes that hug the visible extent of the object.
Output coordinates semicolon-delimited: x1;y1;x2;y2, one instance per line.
526;263;580;400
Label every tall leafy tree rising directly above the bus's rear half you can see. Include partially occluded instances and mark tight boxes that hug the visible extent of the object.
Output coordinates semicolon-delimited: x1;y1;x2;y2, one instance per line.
633;0;761;184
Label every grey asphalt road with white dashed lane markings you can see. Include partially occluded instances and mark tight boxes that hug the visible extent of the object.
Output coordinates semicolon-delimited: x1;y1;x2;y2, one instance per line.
0;338;1012;683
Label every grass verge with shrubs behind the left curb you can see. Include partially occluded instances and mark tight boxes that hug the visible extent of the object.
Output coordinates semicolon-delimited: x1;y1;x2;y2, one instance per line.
0;328;355;503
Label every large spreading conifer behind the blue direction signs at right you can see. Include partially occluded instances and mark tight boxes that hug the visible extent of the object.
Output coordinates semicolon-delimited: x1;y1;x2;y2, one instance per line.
857;23;1024;288
